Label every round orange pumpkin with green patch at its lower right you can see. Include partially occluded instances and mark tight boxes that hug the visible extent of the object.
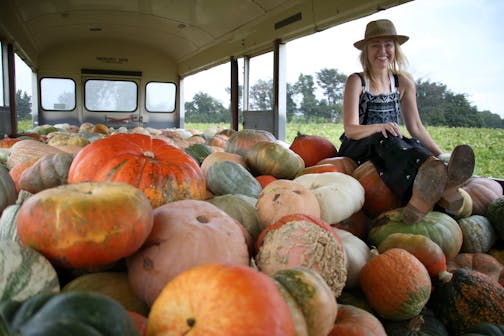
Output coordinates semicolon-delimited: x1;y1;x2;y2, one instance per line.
360;248;432;320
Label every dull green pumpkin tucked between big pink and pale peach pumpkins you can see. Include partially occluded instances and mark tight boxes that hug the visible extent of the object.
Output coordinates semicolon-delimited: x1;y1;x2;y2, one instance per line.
208;194;261;242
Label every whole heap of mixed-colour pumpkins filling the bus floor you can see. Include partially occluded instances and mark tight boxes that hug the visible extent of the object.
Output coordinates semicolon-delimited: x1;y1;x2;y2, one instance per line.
0;123;504;336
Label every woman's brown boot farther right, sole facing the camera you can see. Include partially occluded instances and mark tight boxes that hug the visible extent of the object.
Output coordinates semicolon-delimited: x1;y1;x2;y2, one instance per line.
439;145;475;212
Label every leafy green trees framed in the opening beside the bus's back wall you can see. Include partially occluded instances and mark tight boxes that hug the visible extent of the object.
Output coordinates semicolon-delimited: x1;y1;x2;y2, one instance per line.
185;91;227;123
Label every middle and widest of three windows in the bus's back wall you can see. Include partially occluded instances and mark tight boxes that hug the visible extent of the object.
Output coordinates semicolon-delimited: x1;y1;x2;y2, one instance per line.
84;79;138;112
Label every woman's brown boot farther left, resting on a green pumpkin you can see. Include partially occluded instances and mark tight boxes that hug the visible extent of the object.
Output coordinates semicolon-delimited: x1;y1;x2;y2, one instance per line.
403;157;448;224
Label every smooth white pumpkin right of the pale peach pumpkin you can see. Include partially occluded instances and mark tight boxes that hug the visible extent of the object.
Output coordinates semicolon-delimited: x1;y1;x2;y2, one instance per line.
294;172;364;224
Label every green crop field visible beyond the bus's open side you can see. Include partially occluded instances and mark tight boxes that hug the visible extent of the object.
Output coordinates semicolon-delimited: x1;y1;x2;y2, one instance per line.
185;123;504;179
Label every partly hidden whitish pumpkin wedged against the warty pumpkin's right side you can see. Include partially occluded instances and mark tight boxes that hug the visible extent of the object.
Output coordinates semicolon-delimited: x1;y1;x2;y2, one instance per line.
332;227;371;288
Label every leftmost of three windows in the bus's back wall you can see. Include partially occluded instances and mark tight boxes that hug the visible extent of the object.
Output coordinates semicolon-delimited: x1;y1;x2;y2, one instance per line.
40;78;75;111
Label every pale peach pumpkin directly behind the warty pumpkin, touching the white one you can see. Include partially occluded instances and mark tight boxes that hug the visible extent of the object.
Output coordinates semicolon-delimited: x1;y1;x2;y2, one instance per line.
256;180;320;229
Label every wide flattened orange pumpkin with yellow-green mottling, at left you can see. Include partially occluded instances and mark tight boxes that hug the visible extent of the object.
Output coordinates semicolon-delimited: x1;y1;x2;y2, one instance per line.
16;182;153;268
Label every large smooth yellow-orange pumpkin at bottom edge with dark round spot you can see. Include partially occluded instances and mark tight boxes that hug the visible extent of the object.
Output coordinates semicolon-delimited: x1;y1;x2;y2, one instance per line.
147;264;295;336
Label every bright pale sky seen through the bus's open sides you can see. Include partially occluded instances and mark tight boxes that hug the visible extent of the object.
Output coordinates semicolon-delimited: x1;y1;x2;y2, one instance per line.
10;0;504;118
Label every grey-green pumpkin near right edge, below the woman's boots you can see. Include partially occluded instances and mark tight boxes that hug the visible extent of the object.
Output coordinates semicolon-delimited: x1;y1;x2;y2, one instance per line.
457;215;497;253
